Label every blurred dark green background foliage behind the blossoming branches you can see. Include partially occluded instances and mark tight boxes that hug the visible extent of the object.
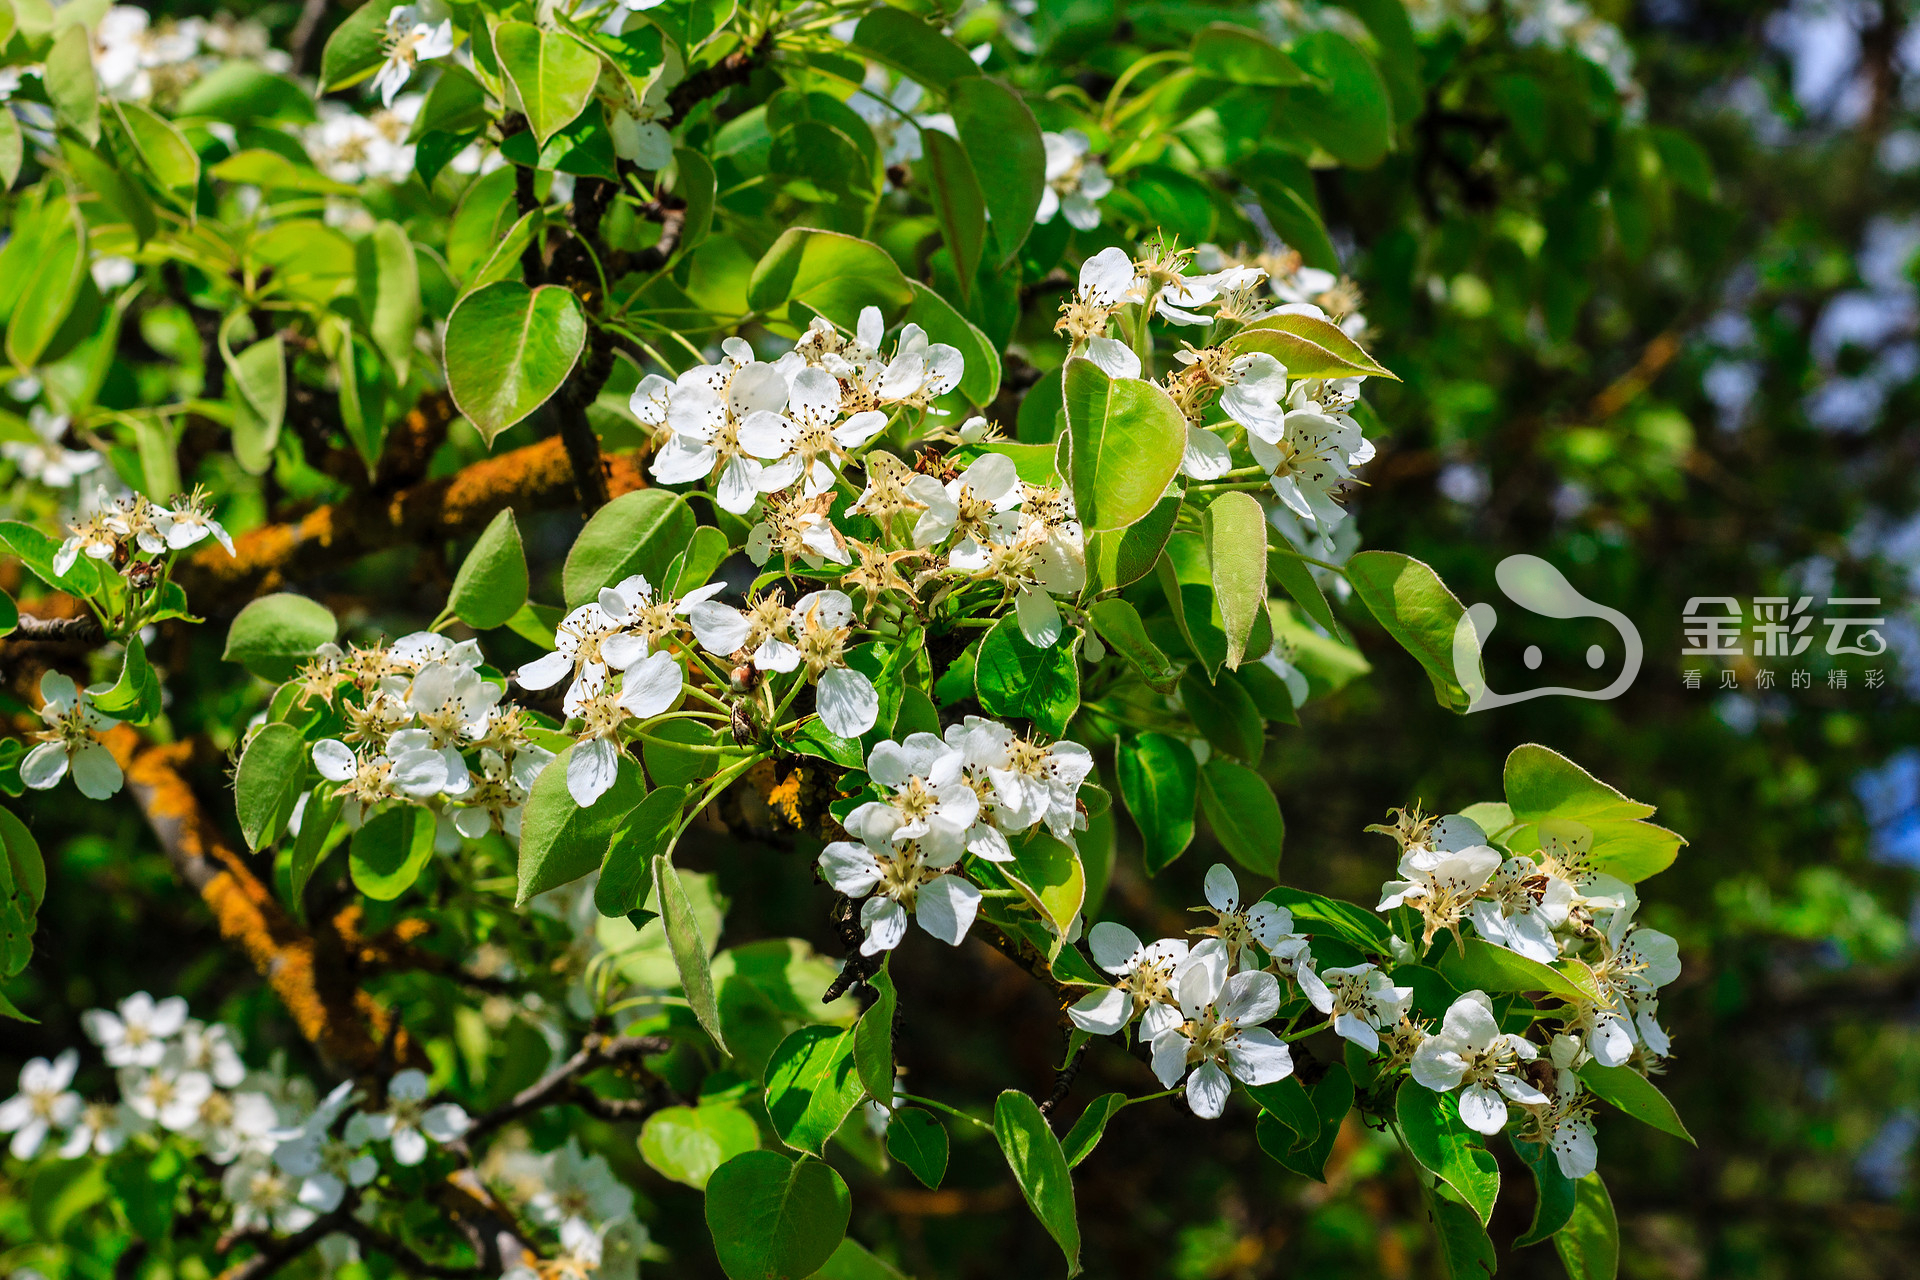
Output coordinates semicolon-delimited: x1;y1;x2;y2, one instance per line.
0;0;1920;1280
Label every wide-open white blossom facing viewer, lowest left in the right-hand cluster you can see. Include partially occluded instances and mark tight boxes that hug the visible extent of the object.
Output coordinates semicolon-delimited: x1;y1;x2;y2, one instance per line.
1152;942;1294;1119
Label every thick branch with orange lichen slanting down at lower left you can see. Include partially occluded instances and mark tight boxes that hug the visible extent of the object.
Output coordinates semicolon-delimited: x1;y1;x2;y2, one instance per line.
102;725;420;1075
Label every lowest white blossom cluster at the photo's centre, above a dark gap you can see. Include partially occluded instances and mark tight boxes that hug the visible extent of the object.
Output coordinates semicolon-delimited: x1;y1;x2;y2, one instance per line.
820;716;1092;956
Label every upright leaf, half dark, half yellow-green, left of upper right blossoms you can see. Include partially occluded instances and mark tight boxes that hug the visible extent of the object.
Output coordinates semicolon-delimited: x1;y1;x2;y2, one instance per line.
1064;357;1182;545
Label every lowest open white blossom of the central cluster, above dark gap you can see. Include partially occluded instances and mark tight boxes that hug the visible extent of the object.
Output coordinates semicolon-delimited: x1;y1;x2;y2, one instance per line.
820;809;979;956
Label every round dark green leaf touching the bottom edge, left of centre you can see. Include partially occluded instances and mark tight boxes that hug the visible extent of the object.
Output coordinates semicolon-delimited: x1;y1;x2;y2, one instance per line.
707;1151;852;1280
